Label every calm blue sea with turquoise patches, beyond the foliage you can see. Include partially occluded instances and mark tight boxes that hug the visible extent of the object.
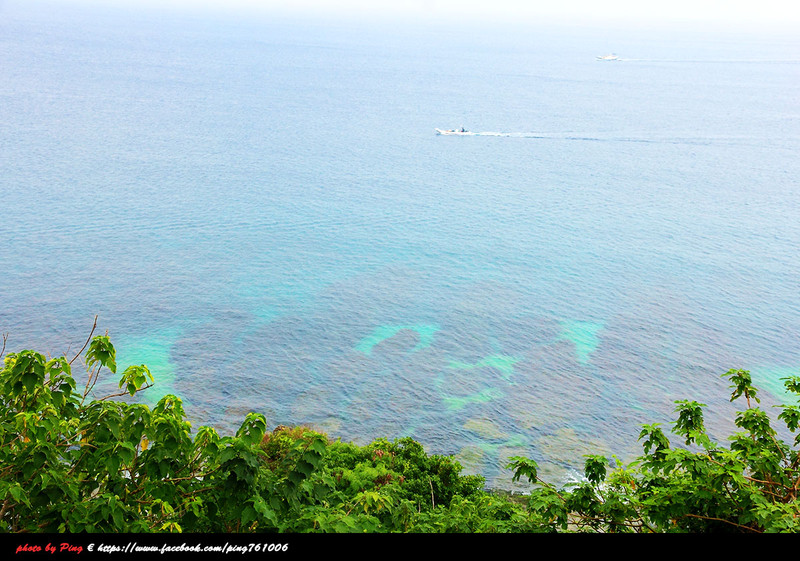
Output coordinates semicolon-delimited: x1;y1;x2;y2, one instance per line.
0;1;800;485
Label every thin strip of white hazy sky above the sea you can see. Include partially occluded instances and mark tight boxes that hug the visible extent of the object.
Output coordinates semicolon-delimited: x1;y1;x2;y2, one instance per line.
59;0;800;29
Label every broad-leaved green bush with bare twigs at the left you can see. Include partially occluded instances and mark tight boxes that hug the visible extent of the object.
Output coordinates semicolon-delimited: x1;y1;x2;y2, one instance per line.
0;336;274;532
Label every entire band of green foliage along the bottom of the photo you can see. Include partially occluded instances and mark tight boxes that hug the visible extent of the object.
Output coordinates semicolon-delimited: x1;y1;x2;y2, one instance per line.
0;328;800;532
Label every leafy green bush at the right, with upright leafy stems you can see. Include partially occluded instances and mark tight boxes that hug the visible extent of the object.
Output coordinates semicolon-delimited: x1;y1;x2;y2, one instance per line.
508;370;800;532
